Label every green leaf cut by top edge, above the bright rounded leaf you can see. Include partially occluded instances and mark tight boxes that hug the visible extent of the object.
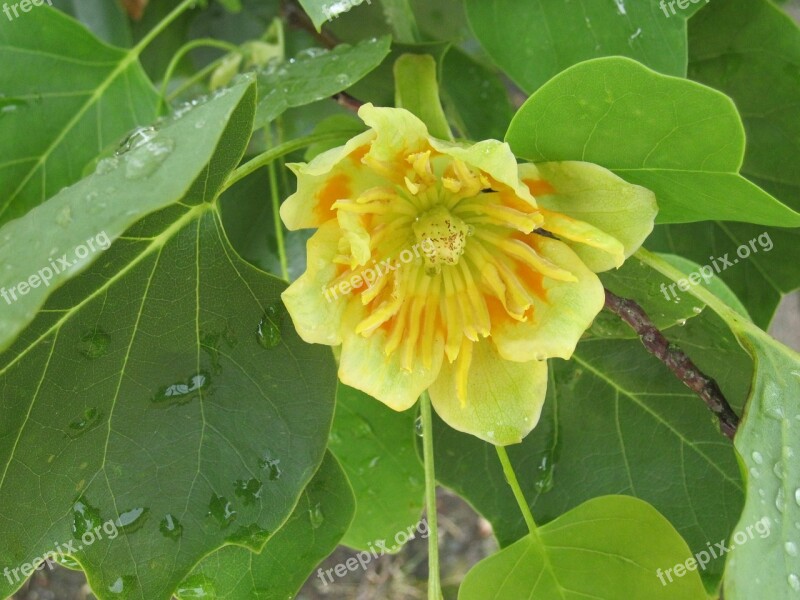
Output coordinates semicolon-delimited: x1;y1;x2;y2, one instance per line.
466;0;691;93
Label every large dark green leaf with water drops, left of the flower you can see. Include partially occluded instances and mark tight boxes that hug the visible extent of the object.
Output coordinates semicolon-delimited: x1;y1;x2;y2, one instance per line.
0;79;335;600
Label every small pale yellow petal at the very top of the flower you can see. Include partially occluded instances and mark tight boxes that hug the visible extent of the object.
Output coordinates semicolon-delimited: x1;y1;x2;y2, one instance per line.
358;103;428;163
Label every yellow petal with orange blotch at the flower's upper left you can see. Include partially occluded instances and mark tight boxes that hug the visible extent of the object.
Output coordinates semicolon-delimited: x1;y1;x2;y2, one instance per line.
281;131;380;230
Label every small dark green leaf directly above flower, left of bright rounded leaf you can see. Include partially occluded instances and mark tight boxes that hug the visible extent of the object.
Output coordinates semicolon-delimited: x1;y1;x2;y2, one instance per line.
442;47;514;140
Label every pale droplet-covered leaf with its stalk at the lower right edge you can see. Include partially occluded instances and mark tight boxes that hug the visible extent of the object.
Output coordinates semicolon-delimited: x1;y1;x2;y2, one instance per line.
640;252;800;600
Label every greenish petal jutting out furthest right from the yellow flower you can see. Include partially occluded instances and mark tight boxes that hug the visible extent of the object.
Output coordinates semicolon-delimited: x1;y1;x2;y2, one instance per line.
519;161;658;273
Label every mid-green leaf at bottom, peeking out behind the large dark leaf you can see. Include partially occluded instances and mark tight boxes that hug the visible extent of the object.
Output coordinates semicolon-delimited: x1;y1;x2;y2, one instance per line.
176;453;355;600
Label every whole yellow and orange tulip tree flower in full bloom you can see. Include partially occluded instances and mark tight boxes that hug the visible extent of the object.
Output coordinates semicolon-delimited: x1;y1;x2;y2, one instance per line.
281;104;657;444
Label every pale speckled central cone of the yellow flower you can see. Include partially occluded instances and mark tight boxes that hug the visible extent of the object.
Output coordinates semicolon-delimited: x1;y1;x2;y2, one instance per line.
413;206;472;275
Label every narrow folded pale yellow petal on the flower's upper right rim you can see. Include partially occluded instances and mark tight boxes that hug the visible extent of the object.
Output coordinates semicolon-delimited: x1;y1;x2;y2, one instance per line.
431;139;537;208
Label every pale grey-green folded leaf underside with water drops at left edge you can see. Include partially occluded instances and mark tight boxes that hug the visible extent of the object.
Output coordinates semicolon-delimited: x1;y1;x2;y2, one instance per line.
0;82;254;350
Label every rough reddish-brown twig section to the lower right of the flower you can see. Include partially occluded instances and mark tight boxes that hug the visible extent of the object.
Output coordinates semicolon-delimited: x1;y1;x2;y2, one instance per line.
606;290;739;439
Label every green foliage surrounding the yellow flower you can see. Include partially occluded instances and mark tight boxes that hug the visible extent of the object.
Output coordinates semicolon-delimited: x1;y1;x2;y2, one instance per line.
0;0;800;600
